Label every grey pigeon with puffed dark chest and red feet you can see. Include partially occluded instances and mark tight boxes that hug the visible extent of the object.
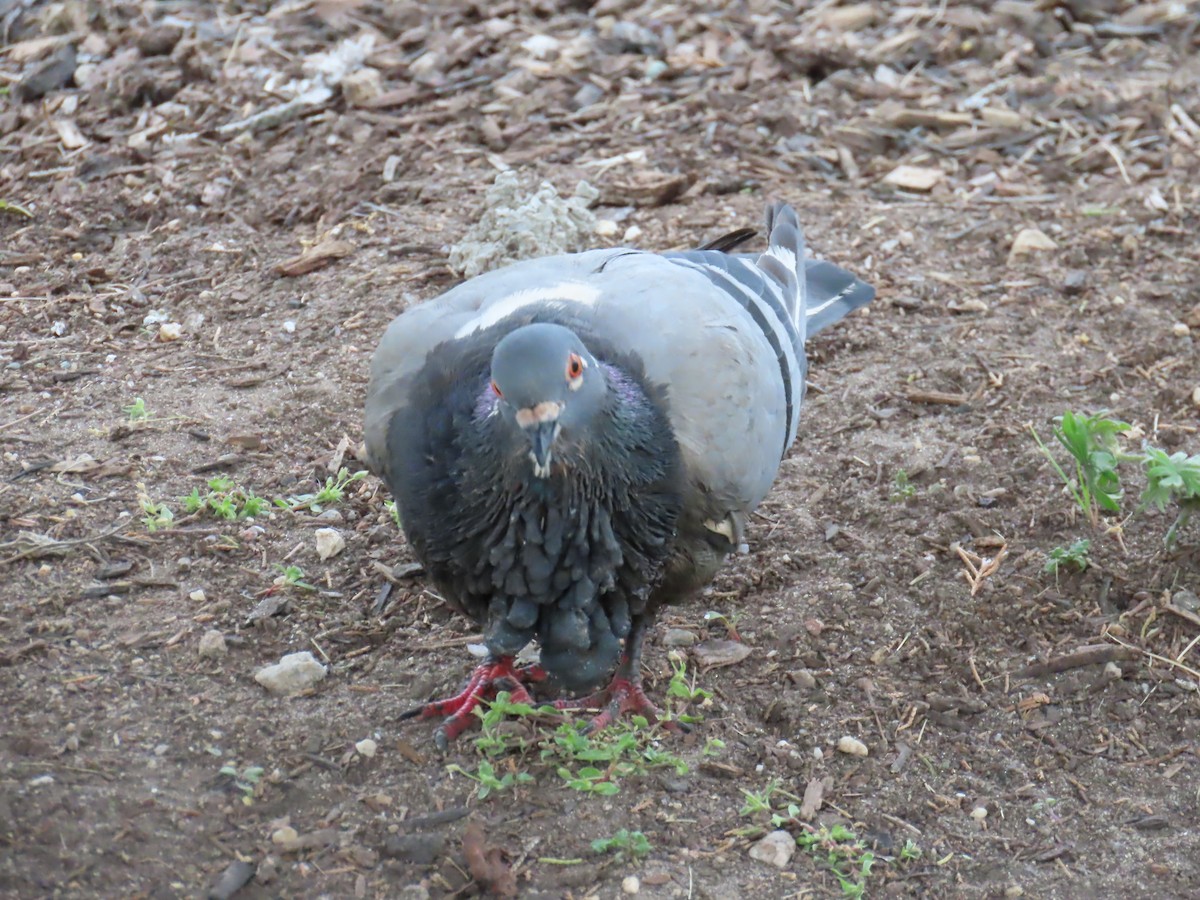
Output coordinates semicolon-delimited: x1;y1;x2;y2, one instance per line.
365;203;875;748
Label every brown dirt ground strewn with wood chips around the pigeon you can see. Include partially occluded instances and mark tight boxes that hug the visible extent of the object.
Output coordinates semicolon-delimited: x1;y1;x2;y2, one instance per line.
0;0;1200;900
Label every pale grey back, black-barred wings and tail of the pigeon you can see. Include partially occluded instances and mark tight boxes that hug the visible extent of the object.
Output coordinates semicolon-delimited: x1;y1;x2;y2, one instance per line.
366;205;874;547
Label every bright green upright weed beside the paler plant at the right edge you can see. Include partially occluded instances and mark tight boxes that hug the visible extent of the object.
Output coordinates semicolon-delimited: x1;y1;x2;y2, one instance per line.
1030;410;1129;528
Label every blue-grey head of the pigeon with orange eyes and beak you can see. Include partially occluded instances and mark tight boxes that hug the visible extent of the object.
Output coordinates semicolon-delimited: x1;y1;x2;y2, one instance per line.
492;323;607;478
